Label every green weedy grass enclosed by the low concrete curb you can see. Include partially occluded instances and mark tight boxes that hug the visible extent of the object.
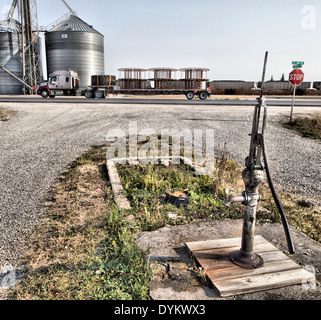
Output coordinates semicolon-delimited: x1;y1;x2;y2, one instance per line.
118;162;243;231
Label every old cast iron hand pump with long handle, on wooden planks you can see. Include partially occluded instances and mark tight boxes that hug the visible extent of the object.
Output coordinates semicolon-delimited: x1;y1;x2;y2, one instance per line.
225;52;294;269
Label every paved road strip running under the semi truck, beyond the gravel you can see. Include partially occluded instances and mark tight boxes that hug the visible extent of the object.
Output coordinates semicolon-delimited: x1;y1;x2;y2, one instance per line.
0;96;321;107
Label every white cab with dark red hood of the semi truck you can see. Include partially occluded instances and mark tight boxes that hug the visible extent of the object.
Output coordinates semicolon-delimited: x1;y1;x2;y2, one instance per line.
37;70;80;98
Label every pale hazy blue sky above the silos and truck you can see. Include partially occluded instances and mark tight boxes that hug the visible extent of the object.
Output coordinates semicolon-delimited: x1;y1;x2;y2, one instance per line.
0;0;321;81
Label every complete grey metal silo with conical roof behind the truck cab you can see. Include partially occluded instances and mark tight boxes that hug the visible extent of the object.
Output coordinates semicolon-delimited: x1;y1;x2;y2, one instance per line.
45;14;105;89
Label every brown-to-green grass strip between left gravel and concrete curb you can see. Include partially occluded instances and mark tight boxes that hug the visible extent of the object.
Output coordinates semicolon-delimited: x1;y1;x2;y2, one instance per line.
10;147;150;300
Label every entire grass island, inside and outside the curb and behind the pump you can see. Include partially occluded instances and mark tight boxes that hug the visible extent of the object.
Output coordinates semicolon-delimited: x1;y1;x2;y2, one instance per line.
10;140;321;300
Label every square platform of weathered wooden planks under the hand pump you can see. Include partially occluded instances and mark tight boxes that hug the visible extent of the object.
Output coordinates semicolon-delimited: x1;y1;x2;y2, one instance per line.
186;236;315;297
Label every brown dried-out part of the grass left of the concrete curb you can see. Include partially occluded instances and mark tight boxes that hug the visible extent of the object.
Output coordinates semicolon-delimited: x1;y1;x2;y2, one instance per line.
26;164;108;269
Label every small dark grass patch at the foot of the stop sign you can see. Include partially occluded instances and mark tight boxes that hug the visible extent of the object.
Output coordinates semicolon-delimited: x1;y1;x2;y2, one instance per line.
283;114;321;139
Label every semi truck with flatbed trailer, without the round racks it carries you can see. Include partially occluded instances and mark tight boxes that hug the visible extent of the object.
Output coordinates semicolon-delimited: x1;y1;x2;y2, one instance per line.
37;70;211;100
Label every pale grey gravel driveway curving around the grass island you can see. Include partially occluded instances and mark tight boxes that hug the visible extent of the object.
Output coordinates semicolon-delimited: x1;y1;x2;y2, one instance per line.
0;103;321;267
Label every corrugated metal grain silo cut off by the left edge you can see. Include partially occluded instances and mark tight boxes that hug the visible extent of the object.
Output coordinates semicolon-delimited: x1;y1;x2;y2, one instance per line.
0;18;23;95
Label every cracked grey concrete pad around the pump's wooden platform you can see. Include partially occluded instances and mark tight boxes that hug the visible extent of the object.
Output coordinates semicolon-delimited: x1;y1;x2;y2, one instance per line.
138;220;321;300
